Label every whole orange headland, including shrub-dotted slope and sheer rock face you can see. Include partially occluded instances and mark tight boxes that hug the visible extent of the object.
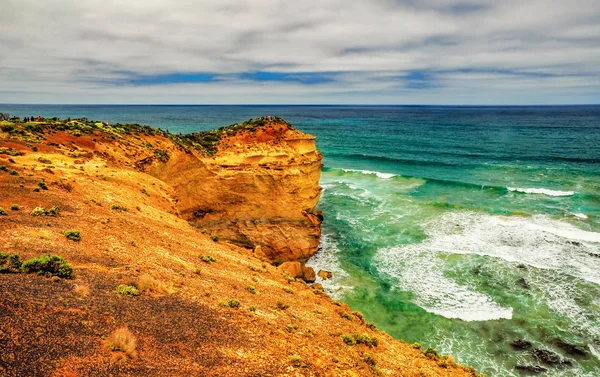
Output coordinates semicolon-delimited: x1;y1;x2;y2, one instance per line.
0;120;475;377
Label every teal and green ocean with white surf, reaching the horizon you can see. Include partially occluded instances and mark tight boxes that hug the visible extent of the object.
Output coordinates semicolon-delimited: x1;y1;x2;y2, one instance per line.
0;105;600;377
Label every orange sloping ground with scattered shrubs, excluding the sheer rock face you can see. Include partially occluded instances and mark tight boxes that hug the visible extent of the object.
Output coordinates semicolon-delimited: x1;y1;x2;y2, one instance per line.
0;117;475;376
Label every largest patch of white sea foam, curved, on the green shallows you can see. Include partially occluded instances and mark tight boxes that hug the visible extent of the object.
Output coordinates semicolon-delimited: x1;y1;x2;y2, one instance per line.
374;211;600;321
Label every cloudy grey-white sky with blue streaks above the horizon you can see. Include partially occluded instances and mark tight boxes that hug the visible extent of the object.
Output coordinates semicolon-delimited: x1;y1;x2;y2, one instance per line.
0;0;600;105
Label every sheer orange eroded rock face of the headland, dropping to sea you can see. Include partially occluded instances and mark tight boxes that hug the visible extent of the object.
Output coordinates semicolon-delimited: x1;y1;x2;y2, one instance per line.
138;118;322;264
